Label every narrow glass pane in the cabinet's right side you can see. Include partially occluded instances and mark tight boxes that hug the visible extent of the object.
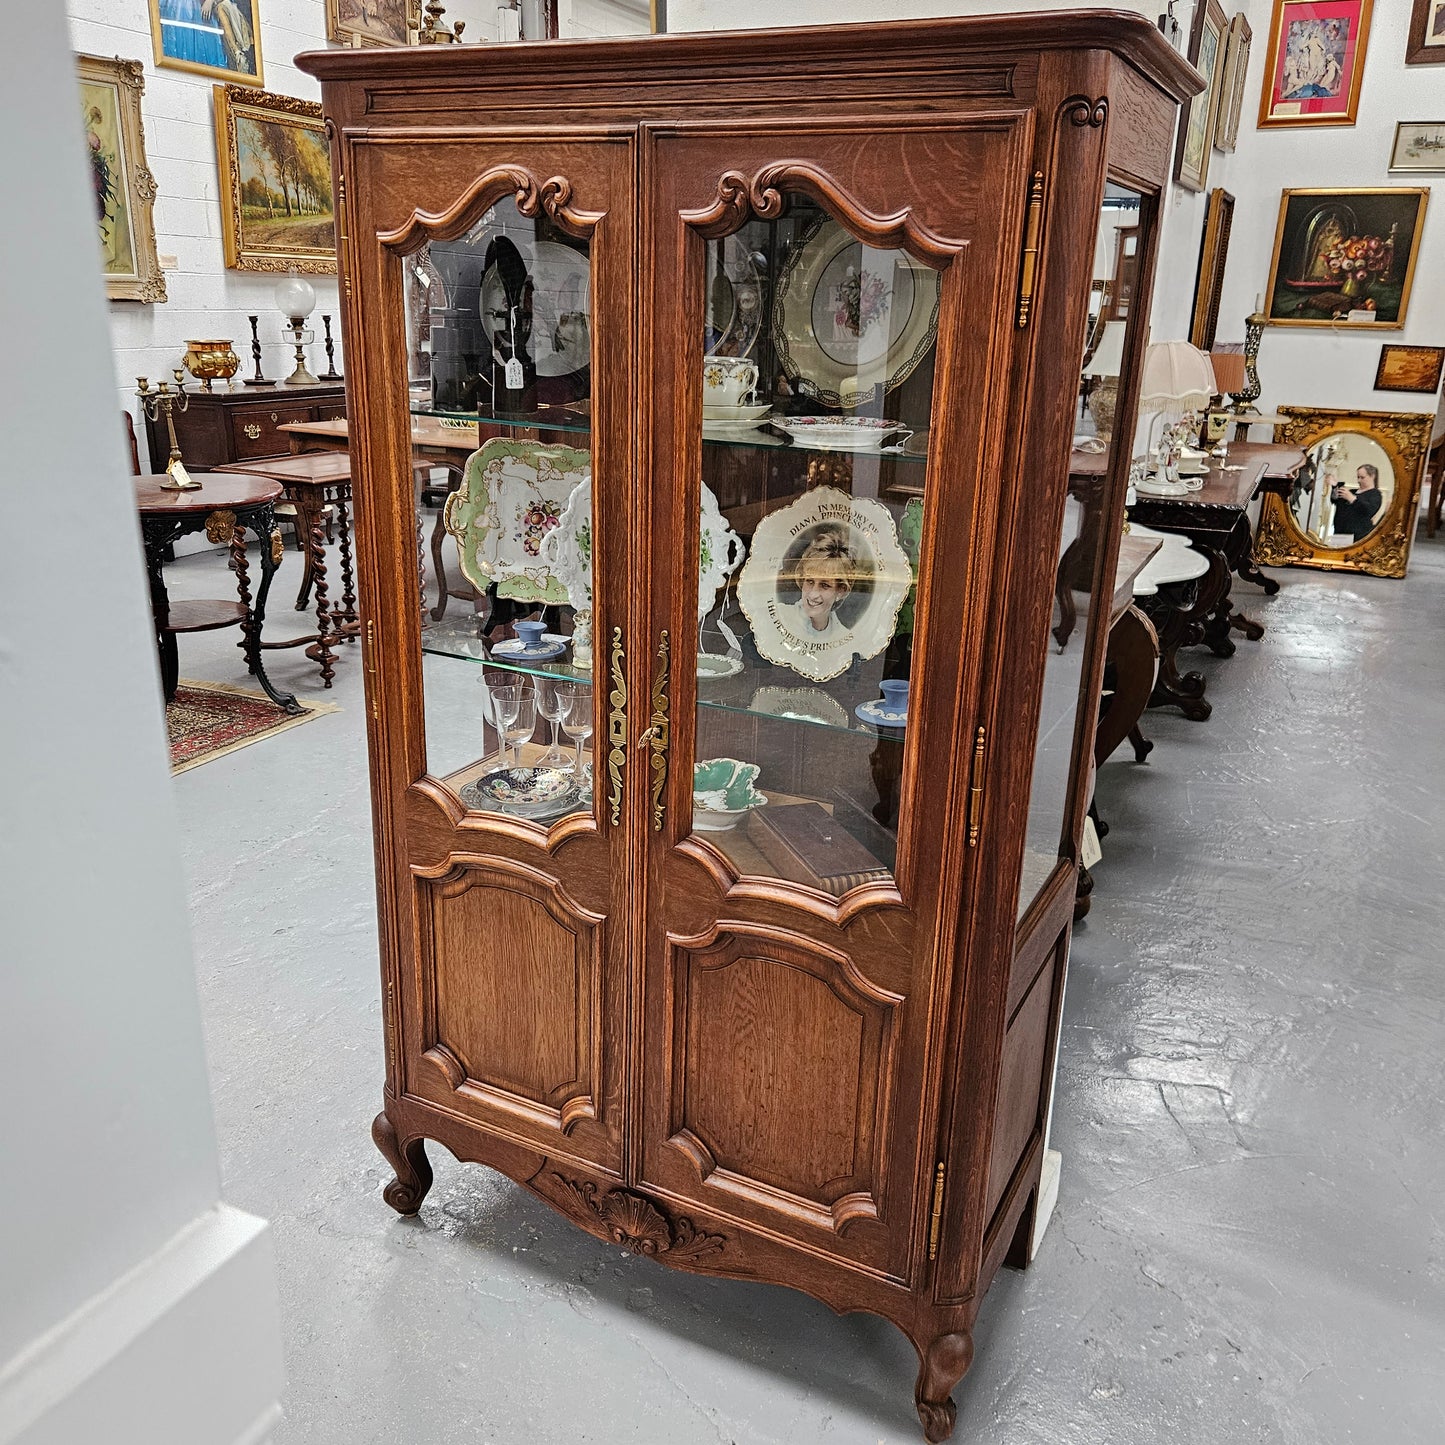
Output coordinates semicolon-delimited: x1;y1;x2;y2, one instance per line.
1019;184;1140;918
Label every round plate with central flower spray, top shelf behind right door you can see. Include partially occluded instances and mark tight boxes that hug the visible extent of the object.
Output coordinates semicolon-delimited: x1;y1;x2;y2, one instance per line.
773;217;939;409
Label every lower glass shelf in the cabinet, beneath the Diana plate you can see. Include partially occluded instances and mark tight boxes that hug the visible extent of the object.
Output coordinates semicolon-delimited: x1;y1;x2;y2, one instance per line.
422;624;905;744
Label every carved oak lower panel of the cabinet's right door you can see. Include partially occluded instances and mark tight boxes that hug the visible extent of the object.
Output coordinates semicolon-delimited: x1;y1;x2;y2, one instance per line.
668;933;902;1233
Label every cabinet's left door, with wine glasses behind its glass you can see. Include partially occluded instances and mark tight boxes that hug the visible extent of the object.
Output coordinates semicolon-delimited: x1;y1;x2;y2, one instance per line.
347;131;637;1173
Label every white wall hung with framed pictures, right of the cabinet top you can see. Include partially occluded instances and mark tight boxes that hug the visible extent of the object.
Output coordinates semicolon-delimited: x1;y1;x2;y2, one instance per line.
668;0;1445;412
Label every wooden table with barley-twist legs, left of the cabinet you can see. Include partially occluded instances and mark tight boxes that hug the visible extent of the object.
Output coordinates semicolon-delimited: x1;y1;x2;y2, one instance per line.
236;453;360;688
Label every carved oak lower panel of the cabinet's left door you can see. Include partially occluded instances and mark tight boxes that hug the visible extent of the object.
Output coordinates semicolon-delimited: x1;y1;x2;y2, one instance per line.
422;867;603;1131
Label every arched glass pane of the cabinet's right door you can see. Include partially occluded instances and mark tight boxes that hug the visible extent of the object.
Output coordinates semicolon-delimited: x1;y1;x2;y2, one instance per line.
675;194;939;896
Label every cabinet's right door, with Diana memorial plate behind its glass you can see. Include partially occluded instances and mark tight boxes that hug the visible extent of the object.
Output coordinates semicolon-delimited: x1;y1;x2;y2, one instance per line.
637;111;1032;1279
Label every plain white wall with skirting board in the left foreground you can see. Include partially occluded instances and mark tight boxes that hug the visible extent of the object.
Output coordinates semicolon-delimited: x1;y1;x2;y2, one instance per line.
0;4;280;1445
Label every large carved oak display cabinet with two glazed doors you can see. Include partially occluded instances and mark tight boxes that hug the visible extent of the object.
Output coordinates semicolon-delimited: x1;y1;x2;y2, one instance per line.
298;13;1199;1441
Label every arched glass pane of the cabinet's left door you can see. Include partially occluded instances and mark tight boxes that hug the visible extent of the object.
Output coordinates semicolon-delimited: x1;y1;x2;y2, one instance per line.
402;198;601;827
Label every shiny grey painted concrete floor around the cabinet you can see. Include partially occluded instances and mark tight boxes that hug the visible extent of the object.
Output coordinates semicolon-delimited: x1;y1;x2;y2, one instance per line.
161;523;1445;1445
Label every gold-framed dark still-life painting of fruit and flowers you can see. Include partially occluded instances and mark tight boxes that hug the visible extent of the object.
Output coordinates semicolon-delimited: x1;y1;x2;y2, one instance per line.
1266;186;1431;329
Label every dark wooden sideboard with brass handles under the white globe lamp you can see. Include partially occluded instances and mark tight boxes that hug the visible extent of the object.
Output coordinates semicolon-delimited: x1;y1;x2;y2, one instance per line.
146;381;347;473
